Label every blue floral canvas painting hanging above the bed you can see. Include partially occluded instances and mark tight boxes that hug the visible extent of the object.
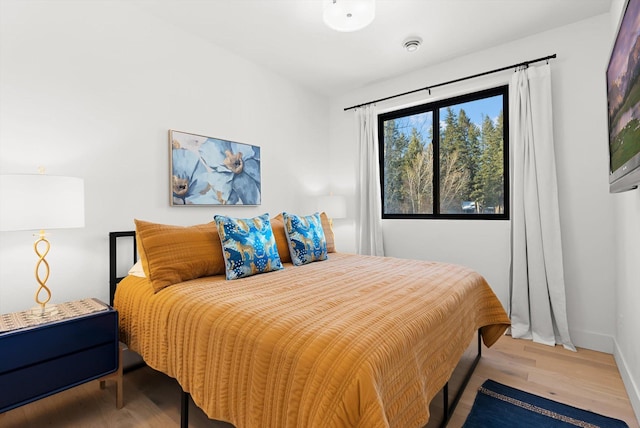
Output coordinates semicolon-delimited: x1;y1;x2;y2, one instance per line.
169;130;262;206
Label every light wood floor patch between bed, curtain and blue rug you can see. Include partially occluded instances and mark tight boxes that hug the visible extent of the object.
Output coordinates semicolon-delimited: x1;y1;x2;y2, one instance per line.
449;336;640;428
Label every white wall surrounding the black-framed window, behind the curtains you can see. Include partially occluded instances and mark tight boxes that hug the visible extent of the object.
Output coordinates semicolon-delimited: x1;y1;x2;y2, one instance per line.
331;15;615;352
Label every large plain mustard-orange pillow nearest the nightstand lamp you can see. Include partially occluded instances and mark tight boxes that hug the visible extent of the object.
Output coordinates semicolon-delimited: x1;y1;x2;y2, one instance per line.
135;220;224;293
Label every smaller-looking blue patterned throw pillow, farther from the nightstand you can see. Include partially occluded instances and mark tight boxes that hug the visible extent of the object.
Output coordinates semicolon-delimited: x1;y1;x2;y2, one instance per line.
282;213;327;266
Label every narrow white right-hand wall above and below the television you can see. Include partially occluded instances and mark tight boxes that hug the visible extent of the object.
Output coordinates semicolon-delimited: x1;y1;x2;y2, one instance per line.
610;0;640;418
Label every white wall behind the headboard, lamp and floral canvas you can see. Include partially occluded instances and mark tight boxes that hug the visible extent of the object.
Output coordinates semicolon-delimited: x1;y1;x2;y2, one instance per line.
0;0;329;313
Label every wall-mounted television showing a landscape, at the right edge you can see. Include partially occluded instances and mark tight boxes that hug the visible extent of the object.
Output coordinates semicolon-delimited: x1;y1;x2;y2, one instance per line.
607;0;640;193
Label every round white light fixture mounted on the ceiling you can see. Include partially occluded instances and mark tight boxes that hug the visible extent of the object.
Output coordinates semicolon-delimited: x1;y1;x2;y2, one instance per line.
322;0;376;32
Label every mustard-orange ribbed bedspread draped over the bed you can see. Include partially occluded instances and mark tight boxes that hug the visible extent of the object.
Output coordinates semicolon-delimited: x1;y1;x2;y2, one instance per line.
114;253;509;428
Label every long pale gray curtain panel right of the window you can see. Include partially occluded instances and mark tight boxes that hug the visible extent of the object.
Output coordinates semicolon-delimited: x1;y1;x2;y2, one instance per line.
509;64;575;351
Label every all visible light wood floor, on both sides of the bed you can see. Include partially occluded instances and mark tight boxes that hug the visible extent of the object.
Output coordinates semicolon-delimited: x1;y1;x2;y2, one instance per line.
0;336;639;428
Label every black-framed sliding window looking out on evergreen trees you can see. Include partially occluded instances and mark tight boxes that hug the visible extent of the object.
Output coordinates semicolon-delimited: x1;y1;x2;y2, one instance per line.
378;86;509;220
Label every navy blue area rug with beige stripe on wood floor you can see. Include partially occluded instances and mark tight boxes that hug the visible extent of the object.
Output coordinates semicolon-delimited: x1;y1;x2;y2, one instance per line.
464;380;628;428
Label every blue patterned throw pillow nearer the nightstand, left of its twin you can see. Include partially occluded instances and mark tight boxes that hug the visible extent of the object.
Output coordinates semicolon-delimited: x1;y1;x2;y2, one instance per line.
214;214;283;279
